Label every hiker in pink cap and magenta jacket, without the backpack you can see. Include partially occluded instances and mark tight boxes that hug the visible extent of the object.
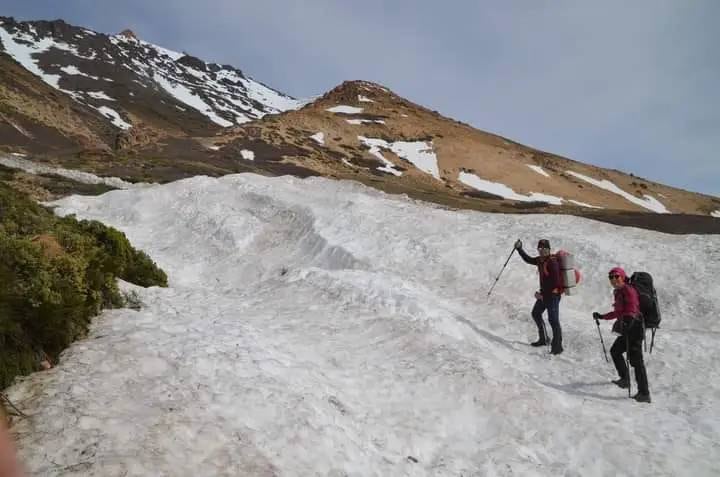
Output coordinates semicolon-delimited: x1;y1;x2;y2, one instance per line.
593;267;650;403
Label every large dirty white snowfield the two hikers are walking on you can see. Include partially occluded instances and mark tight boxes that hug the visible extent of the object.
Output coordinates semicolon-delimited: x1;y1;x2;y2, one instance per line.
8;174;720;476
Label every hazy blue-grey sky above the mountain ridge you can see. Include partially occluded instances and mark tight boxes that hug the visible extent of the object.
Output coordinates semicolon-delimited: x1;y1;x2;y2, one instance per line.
0;0;720;196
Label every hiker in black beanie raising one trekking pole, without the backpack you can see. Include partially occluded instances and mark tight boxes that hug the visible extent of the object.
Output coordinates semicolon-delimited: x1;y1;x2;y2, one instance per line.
515;239;563;354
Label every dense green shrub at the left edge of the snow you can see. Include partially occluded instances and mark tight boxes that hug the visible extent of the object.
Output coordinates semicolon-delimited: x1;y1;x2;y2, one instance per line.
0;183;167;389
